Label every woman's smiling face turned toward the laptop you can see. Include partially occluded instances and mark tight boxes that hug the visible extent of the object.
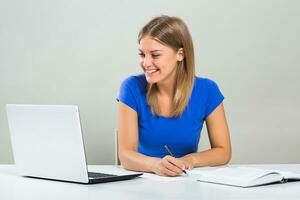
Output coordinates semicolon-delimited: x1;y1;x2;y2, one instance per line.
139;36;183;83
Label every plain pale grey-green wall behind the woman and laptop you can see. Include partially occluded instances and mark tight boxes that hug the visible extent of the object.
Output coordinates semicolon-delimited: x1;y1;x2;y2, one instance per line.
0;0;300;164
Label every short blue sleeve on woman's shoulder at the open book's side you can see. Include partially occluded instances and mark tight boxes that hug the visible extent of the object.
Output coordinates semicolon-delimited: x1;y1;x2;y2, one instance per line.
205;79;224;118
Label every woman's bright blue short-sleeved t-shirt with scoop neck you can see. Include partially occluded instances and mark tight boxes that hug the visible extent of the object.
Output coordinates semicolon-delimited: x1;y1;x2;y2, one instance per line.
118;74;224;158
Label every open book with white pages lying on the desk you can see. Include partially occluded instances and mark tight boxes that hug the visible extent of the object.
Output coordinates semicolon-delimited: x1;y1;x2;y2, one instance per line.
198;167;300;187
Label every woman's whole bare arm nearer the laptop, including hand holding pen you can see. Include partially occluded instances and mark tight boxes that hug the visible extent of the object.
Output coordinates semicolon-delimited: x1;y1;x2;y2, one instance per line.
118;102;185;176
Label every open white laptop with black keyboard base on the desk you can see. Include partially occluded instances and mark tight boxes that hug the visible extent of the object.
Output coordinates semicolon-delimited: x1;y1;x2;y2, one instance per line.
6;104;142;184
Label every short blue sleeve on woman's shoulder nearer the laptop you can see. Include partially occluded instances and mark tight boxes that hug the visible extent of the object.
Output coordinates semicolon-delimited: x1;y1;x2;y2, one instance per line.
117;77;137;111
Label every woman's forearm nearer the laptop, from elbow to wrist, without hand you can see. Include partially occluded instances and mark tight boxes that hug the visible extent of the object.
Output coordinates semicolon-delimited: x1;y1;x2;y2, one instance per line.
120;150;159;172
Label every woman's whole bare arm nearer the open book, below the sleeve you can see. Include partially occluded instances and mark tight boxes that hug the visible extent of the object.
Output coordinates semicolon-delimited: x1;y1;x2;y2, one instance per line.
181;103;231;168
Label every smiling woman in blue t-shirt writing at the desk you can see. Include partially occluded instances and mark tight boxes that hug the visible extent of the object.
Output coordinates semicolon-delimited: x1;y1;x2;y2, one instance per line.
118;16;231;176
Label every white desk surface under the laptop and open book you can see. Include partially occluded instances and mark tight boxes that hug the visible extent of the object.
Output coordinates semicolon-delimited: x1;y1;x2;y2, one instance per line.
0;164;300;200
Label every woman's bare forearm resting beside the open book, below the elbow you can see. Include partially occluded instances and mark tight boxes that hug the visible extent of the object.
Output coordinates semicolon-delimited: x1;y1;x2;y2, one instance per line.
187;147;231;167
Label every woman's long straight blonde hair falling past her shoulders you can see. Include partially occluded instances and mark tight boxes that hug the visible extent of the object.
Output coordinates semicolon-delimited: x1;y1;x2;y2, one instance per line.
138;15;195;117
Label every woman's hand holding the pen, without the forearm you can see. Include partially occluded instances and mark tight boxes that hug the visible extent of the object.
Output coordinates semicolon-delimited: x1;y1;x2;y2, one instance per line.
152;155;186;176
